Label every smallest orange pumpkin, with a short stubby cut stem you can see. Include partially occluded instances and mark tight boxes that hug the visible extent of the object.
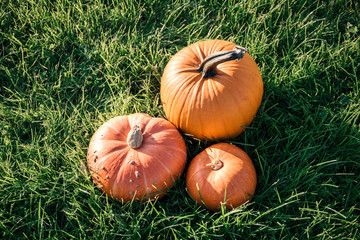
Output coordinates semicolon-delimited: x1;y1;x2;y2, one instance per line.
186;143;256;211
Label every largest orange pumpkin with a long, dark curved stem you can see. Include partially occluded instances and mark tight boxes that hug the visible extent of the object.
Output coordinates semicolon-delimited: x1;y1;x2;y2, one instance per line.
160;40;263;140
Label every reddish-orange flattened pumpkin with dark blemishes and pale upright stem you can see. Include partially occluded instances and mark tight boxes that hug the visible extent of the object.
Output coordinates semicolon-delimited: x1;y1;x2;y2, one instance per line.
87;113;186;202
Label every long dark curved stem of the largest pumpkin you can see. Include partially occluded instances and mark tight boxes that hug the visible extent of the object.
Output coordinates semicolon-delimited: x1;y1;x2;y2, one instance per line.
197;46;247;78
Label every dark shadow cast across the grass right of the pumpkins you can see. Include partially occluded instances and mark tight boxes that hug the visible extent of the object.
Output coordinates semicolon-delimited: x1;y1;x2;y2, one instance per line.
234;72;360;210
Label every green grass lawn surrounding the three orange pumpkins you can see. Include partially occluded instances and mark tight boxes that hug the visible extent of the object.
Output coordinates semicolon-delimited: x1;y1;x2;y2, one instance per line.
0;0;360;239
